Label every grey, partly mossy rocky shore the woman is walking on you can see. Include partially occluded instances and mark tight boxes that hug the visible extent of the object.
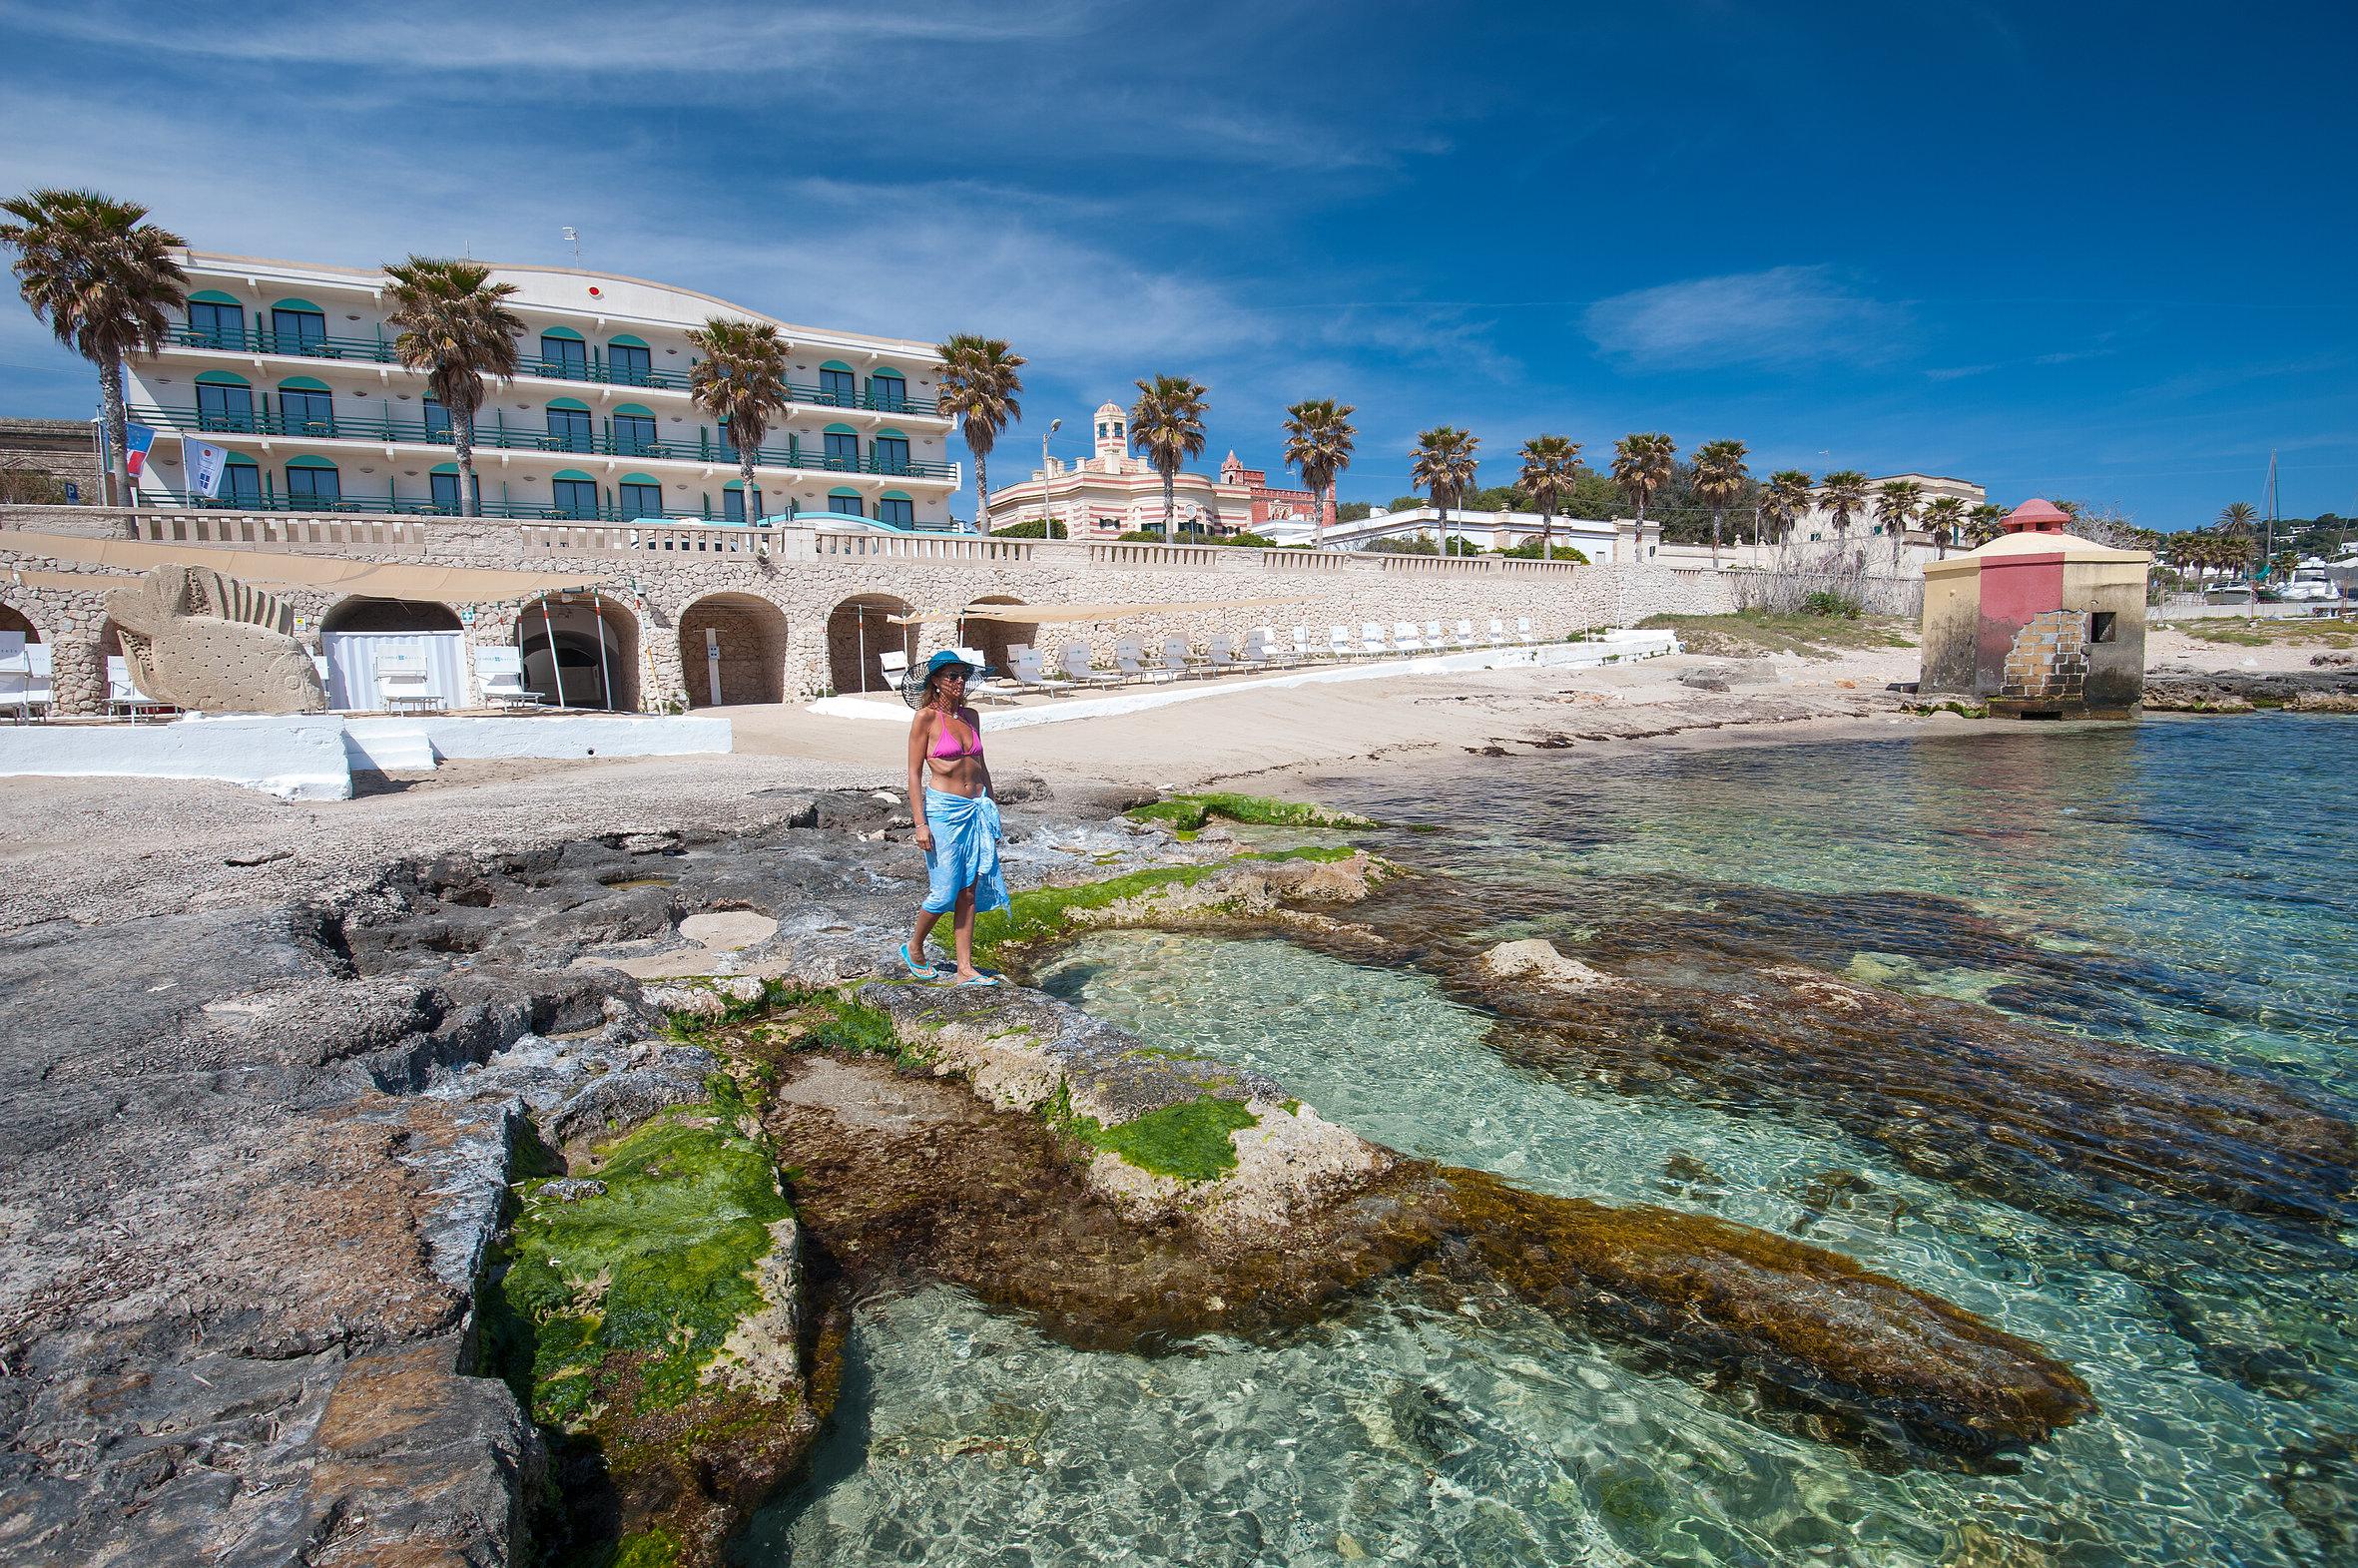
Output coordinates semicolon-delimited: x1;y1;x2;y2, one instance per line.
0;787;2131;1568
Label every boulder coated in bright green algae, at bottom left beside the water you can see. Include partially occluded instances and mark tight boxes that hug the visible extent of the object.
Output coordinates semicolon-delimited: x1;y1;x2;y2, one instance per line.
483;1075;826;1563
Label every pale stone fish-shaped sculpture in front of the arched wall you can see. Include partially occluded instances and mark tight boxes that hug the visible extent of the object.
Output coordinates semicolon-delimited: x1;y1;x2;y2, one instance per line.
106;566;327;712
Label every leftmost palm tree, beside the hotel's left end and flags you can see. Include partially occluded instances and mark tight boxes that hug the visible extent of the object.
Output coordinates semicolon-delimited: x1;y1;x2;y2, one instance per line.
0;189;189;507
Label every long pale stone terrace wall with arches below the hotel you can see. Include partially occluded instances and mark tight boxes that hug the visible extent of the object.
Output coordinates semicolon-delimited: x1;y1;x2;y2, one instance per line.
0;507;1735;712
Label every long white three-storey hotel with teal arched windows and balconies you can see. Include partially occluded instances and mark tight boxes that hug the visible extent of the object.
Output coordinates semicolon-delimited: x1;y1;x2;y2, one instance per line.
130;250;959;528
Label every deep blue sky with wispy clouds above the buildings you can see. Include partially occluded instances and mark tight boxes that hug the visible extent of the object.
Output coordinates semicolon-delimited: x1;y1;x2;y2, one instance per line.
0;0;2358;528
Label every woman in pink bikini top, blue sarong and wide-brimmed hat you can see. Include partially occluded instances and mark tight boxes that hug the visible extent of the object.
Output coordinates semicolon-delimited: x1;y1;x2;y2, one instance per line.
900;649;1007;985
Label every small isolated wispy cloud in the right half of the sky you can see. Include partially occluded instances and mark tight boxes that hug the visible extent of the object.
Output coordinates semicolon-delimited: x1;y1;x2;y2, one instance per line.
1582;266;1908;370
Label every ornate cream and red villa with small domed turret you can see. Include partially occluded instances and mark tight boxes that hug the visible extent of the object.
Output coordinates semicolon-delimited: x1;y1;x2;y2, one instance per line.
988;403;1335;540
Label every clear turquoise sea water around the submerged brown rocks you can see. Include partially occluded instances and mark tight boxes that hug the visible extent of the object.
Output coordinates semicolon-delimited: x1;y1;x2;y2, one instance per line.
743;717;2358;1568
